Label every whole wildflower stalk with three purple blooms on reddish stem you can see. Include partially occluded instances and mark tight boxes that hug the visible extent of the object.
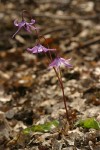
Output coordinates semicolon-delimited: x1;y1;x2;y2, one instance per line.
12;12;72;119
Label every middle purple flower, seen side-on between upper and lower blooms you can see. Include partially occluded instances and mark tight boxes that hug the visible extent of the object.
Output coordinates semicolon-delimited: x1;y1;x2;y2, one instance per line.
27;44;55;54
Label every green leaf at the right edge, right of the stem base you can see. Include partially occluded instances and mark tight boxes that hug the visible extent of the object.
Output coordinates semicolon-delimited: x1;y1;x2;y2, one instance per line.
75;118;100;130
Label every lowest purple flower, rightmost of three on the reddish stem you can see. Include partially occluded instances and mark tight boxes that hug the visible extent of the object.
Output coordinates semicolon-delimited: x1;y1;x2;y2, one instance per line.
49;57;72;69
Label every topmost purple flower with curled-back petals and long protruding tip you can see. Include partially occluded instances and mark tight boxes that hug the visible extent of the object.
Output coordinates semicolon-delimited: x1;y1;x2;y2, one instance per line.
12;19;37;38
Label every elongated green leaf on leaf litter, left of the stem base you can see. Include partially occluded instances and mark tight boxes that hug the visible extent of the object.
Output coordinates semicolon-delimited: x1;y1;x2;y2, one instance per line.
23;120;59;134
